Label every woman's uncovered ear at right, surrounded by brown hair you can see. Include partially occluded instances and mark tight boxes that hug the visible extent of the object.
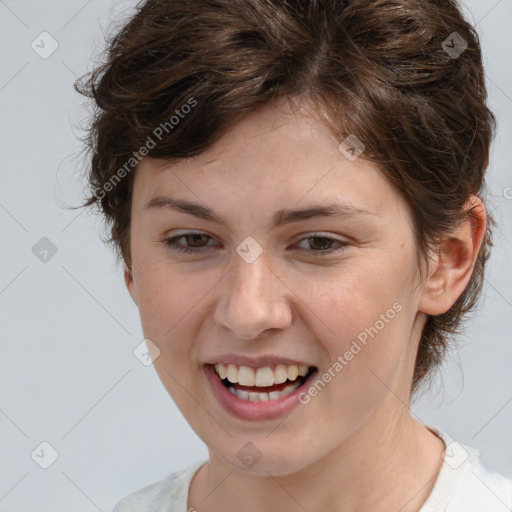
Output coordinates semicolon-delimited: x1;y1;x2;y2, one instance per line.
418;195;487;315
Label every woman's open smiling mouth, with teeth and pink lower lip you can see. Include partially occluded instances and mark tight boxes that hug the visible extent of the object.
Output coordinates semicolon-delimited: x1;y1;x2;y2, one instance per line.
203;363;318;421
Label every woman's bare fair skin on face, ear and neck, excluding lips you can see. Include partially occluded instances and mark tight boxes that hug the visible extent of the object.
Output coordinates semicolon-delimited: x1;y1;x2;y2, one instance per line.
125;96;485;512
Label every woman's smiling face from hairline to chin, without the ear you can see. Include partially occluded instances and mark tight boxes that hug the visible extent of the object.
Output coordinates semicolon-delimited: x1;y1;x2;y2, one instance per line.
126;97;425;475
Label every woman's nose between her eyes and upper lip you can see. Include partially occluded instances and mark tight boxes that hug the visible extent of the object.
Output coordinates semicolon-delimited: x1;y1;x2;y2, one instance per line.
214;251;293;339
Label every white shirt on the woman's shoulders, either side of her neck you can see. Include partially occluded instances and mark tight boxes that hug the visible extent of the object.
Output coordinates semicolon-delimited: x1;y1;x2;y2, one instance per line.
113;427;512;512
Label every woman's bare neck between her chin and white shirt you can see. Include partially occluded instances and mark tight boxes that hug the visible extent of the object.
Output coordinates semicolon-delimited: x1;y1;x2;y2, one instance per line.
189;400;445;512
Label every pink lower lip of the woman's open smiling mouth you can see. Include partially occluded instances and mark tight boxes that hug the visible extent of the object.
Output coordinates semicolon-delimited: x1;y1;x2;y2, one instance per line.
203;364;317;421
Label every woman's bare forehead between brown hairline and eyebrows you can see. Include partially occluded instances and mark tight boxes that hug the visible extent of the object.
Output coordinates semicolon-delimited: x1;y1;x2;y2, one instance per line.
134;97;403;225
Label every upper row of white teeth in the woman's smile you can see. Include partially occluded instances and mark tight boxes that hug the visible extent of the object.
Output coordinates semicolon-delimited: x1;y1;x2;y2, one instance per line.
215;363;309;387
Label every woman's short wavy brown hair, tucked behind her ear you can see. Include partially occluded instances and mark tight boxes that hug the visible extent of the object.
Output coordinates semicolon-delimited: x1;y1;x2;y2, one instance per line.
75;0;496;393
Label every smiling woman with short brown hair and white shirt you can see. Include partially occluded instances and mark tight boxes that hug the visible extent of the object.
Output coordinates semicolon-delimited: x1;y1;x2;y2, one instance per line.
77;0;512;512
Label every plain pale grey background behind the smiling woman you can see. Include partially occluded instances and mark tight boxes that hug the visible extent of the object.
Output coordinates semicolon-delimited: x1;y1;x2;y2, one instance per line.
0;0;512;512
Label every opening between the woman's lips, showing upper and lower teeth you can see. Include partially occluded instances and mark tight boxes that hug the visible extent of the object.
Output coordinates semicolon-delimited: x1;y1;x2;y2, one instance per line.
213;363;316;402
